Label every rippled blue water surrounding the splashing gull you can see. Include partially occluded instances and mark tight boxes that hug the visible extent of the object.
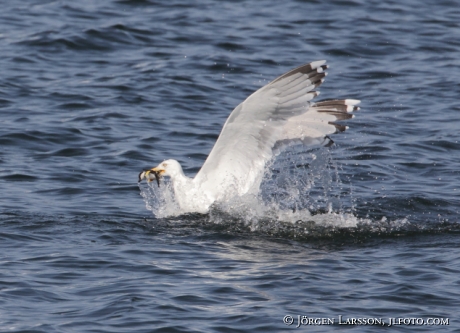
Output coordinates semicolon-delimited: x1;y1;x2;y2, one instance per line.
0;0;460;332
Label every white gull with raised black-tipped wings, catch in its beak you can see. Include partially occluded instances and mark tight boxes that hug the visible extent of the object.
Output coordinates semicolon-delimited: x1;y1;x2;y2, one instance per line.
139;60;360;213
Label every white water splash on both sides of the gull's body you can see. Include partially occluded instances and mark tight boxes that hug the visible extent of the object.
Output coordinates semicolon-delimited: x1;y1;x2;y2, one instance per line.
141;147;356;226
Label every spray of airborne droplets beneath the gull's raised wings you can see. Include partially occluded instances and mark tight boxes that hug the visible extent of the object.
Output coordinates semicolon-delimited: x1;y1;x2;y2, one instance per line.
260;146;353;213
